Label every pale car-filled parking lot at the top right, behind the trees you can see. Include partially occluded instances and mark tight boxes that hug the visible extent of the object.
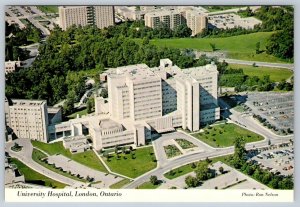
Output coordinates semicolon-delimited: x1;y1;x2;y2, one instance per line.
208;13;261;29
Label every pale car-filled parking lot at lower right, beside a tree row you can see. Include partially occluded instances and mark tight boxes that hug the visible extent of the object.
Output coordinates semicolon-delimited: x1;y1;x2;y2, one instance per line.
252;146;294;175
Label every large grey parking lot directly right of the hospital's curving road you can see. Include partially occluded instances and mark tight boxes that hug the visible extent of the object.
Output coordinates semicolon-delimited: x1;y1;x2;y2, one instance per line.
245;92;294;131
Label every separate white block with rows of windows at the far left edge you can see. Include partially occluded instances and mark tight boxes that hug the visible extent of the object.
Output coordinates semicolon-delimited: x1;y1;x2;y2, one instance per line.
4;98;61;142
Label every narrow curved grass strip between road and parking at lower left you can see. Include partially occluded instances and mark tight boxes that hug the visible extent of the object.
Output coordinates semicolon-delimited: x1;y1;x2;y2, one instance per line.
32;149;86;182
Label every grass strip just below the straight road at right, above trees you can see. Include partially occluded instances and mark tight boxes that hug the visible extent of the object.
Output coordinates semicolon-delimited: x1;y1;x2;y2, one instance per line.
228;64;293;82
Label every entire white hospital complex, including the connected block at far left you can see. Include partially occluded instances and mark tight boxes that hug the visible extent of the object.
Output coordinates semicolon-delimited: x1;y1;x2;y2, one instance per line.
5;59;220;150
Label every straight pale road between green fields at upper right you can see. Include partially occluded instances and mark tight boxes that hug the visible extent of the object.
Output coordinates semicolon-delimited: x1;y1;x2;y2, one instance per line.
219;58;294;70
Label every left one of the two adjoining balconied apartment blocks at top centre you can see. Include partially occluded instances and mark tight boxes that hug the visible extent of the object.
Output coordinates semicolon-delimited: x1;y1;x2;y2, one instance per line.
144;10;183;29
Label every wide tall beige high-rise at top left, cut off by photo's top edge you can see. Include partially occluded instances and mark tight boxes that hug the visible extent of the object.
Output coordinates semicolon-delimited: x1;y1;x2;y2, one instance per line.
59;6;114;30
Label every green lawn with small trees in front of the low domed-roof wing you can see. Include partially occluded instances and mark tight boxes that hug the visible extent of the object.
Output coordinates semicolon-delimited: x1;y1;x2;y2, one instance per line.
103;147;156;178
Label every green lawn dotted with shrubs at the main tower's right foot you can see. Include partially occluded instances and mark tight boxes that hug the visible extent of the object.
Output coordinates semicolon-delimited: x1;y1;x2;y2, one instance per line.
193;124;263;147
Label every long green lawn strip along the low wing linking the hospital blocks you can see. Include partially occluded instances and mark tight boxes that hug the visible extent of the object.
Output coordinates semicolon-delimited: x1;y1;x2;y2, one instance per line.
31;140;107;172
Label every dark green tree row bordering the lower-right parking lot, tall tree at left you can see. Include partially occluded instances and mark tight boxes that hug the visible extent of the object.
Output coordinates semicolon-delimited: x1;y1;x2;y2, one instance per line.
228;137;294;189
